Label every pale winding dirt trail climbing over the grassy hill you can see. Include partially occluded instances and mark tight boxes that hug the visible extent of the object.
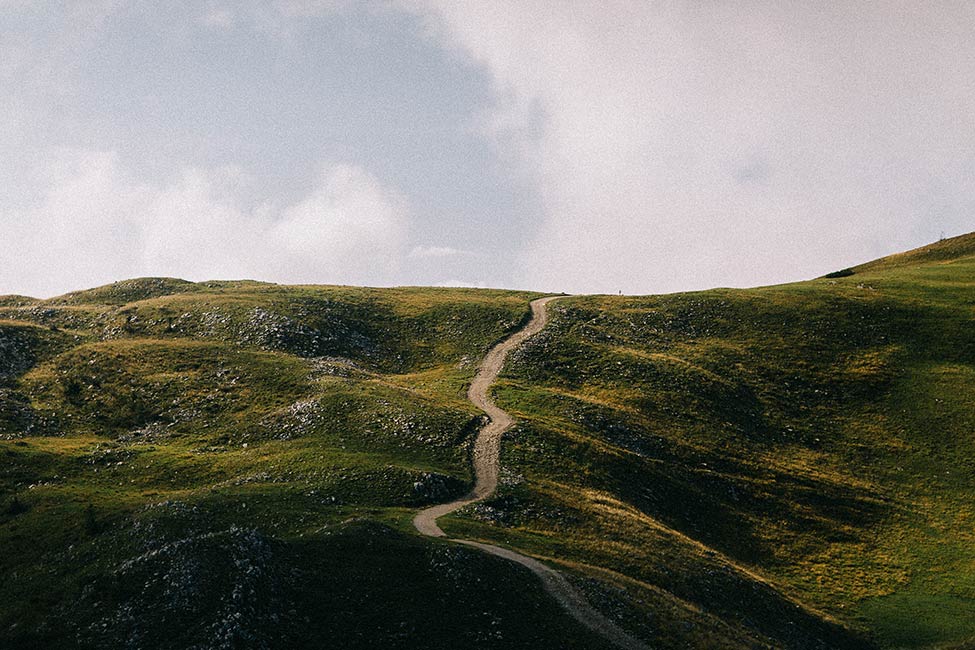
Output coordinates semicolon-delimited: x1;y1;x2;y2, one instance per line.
413;296;649;650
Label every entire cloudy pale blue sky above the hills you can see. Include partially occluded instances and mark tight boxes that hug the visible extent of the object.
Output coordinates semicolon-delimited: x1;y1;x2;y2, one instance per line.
0;0;975;297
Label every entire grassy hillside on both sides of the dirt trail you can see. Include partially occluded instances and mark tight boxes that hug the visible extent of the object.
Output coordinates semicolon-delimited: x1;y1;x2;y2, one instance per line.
0;235;975;649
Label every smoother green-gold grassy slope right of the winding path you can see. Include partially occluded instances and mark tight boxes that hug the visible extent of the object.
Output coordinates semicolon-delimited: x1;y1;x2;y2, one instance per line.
441;230;975;648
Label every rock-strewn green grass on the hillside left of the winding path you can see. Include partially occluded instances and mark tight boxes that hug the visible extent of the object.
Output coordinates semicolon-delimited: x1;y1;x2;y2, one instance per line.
0;279;560;647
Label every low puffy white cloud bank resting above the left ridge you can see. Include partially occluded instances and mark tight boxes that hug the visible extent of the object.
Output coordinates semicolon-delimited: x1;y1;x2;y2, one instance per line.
0;151;409;296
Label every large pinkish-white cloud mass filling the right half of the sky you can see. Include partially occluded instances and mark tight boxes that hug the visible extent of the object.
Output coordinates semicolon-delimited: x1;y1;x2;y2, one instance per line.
401;0;975;293
